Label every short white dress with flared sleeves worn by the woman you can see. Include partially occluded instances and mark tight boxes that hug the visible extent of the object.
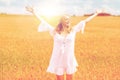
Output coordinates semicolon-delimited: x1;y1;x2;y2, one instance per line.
36;9;85;75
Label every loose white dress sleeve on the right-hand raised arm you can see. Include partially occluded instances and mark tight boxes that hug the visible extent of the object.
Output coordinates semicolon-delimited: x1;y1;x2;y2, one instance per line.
73;21;86;33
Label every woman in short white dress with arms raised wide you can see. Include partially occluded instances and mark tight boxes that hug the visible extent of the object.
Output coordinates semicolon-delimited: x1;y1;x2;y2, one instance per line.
26;7;101;80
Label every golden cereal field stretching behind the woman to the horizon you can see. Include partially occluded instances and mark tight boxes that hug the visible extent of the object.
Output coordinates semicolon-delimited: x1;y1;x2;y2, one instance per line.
0;15;120;80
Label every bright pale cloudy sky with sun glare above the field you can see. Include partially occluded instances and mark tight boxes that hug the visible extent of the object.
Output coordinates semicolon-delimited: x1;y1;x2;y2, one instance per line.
0;0;120;15
